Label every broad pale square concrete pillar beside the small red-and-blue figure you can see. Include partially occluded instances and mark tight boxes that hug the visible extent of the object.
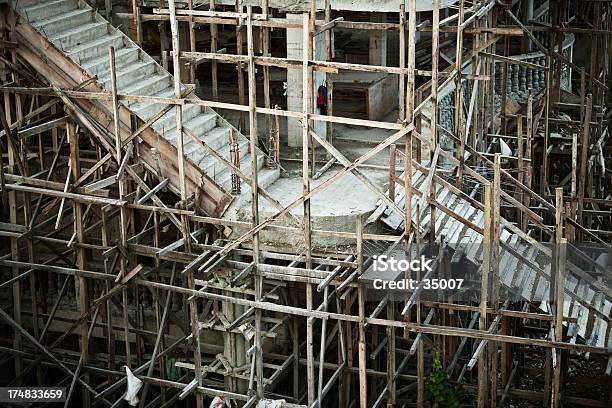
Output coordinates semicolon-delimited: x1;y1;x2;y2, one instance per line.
287;14;327;147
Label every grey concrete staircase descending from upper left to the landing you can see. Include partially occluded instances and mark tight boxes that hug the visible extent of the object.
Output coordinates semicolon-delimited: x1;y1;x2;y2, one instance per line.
13;0;279;202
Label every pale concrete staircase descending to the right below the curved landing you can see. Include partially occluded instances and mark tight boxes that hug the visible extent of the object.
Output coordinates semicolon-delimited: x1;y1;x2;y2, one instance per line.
370;163;612;347
